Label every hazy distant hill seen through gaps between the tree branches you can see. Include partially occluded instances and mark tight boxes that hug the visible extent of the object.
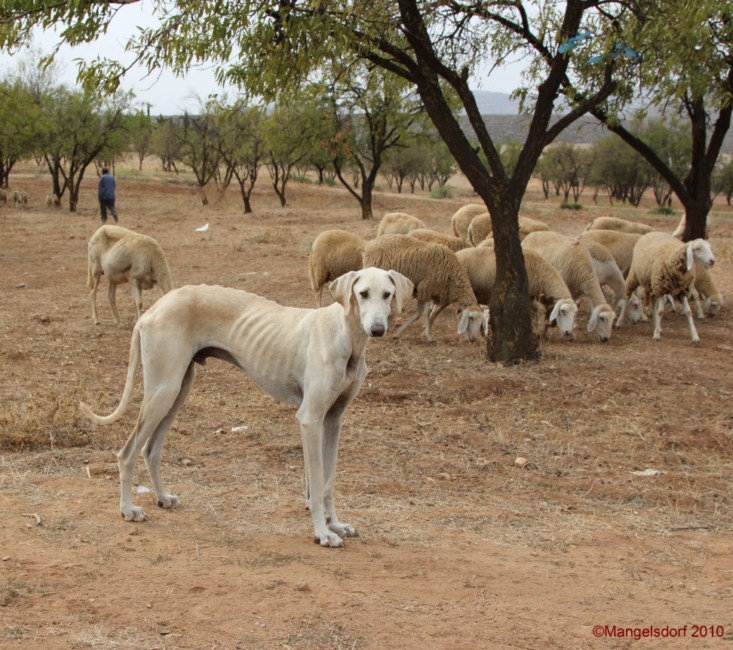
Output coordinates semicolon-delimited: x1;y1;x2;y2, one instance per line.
462;90;733;154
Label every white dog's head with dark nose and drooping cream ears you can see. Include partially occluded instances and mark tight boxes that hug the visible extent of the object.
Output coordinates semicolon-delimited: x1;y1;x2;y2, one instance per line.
328;267;414;336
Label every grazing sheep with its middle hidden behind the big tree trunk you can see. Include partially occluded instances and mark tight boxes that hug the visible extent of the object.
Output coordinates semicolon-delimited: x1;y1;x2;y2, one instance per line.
456;246;578;336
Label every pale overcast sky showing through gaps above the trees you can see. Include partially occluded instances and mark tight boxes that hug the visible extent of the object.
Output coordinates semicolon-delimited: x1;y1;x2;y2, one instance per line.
0;0;521;115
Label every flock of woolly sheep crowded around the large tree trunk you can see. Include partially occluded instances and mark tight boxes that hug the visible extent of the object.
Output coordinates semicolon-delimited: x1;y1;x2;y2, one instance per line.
309;204;722;342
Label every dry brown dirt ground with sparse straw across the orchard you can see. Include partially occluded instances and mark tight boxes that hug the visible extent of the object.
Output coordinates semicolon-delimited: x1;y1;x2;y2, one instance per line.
0;163;733;649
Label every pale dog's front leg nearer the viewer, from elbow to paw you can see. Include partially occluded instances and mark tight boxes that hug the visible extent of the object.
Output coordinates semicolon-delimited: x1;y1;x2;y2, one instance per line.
298;411;344;547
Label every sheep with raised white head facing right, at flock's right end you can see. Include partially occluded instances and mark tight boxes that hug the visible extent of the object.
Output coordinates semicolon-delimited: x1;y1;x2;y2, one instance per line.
616;232;715;343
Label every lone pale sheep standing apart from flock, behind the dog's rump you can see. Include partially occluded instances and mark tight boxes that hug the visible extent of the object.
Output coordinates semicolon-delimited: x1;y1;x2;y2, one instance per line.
87;226;173;325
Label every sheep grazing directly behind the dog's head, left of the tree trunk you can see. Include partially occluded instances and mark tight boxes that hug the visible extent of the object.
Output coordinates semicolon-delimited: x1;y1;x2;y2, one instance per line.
362;235;483;342
